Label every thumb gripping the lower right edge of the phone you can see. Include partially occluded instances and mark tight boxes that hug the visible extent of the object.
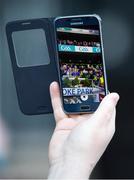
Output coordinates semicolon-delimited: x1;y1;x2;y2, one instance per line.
94;93;119;123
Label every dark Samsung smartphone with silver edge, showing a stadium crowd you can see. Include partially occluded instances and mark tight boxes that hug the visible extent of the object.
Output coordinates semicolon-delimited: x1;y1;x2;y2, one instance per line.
55;15;107;114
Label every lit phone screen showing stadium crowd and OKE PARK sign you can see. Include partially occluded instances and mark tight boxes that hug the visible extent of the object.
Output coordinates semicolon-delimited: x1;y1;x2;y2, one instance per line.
57;25;105;104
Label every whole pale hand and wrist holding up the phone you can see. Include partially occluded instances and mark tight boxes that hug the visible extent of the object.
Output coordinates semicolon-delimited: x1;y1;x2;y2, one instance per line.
48;82;119;179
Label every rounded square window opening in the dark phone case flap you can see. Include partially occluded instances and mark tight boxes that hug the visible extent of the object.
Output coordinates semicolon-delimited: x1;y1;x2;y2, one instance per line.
12;29;50;67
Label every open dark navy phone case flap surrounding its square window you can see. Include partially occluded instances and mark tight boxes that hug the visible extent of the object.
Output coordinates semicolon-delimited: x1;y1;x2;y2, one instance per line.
6;18;58;115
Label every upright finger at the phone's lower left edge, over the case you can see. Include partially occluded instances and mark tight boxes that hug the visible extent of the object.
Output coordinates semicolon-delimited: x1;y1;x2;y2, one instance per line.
50;82;67;122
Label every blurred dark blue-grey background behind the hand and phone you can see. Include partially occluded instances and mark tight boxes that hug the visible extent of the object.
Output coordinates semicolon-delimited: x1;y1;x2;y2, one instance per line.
0;0;134;179
